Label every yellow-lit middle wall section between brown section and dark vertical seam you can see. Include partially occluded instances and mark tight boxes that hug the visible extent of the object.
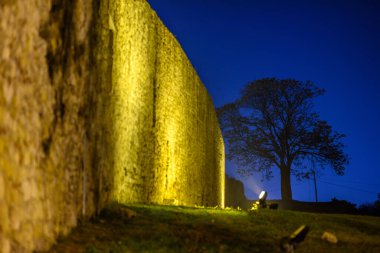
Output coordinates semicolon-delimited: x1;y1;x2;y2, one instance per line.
109;1;157;202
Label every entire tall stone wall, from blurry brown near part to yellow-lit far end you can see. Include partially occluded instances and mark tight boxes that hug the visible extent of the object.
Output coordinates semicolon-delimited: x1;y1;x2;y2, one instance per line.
0;0;224;253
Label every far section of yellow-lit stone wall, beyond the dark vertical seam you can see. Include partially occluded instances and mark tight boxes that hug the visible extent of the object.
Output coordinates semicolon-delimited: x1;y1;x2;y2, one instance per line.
155;18;224;205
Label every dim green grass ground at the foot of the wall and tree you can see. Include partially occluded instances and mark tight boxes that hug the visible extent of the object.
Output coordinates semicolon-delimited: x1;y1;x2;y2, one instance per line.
46;205;380;253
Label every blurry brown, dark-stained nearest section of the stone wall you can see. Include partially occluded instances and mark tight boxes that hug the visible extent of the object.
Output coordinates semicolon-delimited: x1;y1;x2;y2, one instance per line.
0;0;102;253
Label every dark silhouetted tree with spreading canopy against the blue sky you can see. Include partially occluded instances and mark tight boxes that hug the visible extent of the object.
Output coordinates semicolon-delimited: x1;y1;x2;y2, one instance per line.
217;78;348;200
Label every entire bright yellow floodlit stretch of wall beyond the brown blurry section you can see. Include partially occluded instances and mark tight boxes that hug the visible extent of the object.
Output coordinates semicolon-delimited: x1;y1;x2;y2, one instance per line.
107;0;224;206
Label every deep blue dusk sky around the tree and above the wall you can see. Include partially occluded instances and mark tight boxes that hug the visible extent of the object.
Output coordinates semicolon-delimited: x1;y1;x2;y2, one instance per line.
148;0;380;204
